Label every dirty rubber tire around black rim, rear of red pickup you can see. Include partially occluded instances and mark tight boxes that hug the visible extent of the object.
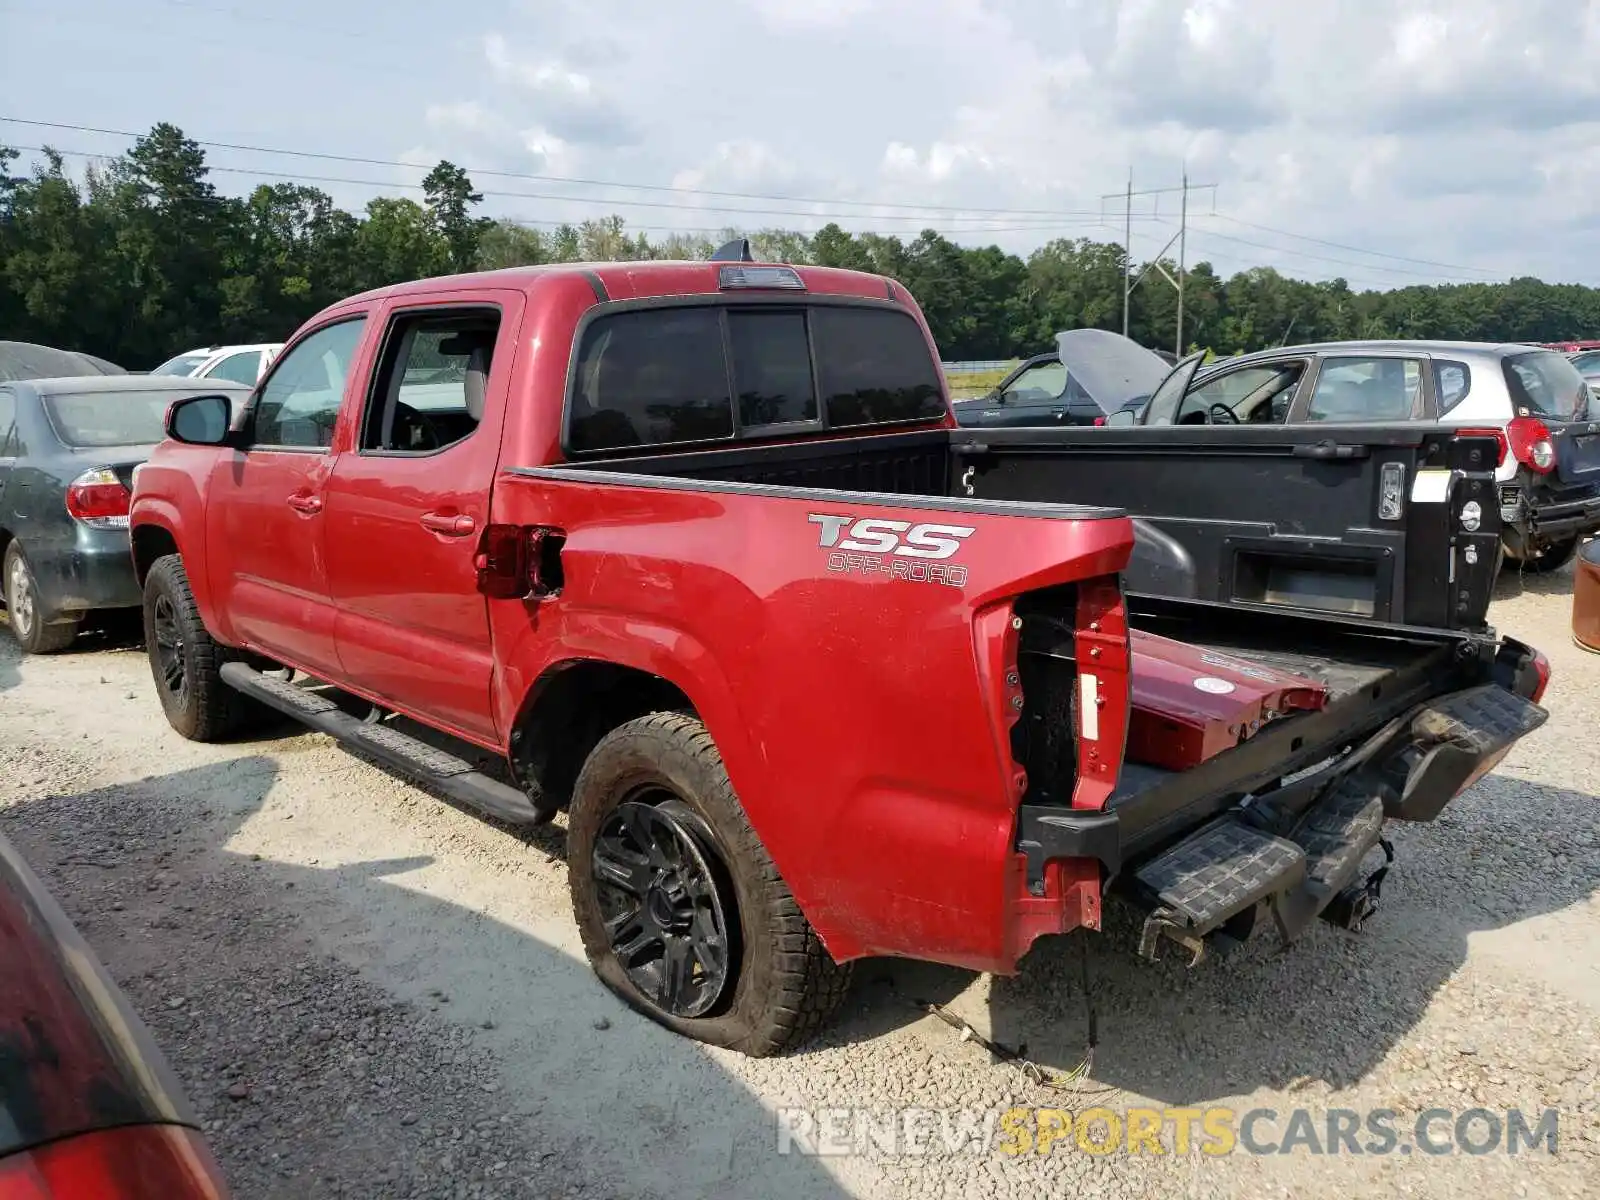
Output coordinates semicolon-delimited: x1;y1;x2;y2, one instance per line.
566;712;850;1058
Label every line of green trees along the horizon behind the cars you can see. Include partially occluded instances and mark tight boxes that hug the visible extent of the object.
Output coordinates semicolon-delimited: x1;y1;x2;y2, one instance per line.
0;125;1600;370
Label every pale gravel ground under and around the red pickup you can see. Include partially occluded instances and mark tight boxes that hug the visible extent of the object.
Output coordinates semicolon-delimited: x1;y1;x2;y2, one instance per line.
0;571;1600;1200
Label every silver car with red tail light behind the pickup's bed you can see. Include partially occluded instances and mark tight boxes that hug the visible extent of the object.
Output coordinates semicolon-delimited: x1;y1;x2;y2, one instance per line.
1110;341;1600;571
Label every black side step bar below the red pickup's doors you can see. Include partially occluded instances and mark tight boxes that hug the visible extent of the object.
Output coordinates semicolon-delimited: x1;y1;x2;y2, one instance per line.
222;662;547;826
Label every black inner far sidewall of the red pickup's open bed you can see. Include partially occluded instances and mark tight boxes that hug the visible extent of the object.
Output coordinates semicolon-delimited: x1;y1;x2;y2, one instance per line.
950;424;1499;629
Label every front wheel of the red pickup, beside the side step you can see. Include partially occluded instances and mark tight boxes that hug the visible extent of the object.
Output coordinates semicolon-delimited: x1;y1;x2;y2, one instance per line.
144;554;262;742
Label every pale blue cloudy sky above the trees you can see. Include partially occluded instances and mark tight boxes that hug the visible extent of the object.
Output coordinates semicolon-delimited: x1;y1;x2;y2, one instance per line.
0;0;1600;288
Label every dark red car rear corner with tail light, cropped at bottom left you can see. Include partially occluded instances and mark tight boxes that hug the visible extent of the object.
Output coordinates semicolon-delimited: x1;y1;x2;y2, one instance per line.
0;835;227;1200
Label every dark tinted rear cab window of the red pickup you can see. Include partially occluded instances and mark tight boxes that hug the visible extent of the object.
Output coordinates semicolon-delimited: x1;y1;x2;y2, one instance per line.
566;304;944;453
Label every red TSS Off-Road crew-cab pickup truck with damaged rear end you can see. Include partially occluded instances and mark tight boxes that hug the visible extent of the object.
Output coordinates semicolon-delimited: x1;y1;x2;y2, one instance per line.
131;254;1549;1054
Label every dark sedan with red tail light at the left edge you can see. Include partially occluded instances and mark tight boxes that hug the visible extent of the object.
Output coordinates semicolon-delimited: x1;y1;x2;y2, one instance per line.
0;374;250;654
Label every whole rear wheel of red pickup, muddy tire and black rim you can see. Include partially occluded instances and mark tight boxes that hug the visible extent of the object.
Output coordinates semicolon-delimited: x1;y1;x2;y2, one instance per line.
566;712;850;1058
